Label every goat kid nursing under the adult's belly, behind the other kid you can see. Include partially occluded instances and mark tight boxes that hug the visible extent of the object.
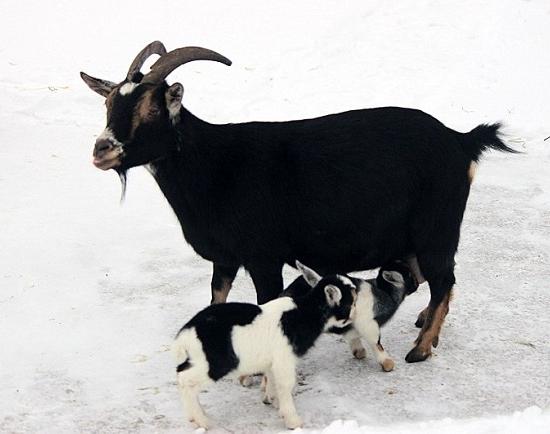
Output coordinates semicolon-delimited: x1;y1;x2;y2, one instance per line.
282;261;418;372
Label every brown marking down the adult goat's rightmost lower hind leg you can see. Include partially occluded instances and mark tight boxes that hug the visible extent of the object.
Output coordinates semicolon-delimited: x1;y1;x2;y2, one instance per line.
405;292;451;363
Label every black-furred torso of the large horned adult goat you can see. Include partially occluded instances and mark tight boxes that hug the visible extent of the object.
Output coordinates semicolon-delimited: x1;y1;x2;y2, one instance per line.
141;108;512;303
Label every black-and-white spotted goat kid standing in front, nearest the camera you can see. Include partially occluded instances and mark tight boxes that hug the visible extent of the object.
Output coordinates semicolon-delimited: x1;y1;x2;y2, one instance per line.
173;263;357;429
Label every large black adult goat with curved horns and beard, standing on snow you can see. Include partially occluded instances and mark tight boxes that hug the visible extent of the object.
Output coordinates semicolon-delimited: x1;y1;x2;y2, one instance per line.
81;42;513;362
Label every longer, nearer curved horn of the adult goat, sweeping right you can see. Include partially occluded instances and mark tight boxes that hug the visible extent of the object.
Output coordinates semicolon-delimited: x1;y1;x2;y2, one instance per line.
141;47;231;83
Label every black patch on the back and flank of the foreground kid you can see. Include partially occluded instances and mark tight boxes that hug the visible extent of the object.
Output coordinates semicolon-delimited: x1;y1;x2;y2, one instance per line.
178;303;262;381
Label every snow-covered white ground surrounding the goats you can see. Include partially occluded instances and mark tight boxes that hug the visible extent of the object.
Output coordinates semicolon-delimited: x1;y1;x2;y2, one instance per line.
0;0;550;433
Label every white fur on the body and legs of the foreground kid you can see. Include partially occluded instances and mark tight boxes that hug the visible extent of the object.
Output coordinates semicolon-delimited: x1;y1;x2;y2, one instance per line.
173;297;302;428
